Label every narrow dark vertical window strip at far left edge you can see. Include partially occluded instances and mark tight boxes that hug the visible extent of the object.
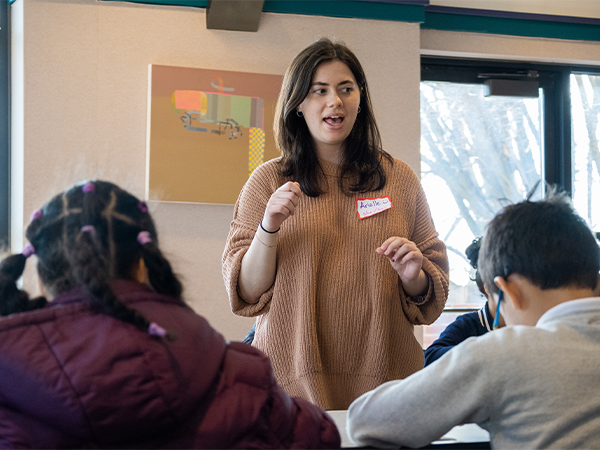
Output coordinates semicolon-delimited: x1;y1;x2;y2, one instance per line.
0;0;10;249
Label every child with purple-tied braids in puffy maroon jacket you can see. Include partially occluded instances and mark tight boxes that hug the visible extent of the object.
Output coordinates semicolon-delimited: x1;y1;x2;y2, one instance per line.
0;181;340;448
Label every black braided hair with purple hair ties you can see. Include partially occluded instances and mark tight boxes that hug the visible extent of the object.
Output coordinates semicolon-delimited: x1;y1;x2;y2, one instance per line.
0;181;182;337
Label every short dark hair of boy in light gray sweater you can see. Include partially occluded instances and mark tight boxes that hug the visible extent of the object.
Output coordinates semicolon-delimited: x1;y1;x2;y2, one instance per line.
478;189;600;293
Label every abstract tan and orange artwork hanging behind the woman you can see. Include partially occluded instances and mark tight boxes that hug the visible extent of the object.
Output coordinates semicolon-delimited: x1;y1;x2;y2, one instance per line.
146;64;283;204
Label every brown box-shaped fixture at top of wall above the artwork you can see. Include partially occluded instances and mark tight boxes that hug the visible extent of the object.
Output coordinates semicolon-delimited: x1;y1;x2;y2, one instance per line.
206;0;264;31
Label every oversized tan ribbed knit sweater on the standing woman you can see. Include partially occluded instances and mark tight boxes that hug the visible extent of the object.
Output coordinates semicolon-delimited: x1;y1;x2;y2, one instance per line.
223;158;448;409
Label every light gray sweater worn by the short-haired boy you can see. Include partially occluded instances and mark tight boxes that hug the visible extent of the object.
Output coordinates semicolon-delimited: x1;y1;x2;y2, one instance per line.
347;297;600;449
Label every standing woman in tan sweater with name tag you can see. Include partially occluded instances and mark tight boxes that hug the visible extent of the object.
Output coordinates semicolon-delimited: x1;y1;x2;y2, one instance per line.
223;39;448;409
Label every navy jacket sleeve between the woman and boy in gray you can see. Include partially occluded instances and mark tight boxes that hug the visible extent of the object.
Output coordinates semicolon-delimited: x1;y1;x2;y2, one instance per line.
425;302;494;366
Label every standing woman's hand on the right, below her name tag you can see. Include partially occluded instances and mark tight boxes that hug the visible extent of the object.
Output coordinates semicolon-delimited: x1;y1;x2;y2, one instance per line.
375;236;429;297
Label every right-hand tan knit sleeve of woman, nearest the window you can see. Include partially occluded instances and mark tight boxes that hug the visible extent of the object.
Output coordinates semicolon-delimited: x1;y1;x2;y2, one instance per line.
402;172;449;325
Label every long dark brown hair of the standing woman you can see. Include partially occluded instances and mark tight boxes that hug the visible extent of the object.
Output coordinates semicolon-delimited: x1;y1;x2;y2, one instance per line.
273;38;392;197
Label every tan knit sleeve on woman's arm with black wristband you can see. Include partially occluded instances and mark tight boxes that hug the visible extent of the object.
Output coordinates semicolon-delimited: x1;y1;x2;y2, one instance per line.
222;164;277;316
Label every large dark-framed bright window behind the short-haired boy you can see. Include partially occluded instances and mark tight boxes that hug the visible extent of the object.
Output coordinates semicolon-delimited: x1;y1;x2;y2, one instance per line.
421;58;600;347
